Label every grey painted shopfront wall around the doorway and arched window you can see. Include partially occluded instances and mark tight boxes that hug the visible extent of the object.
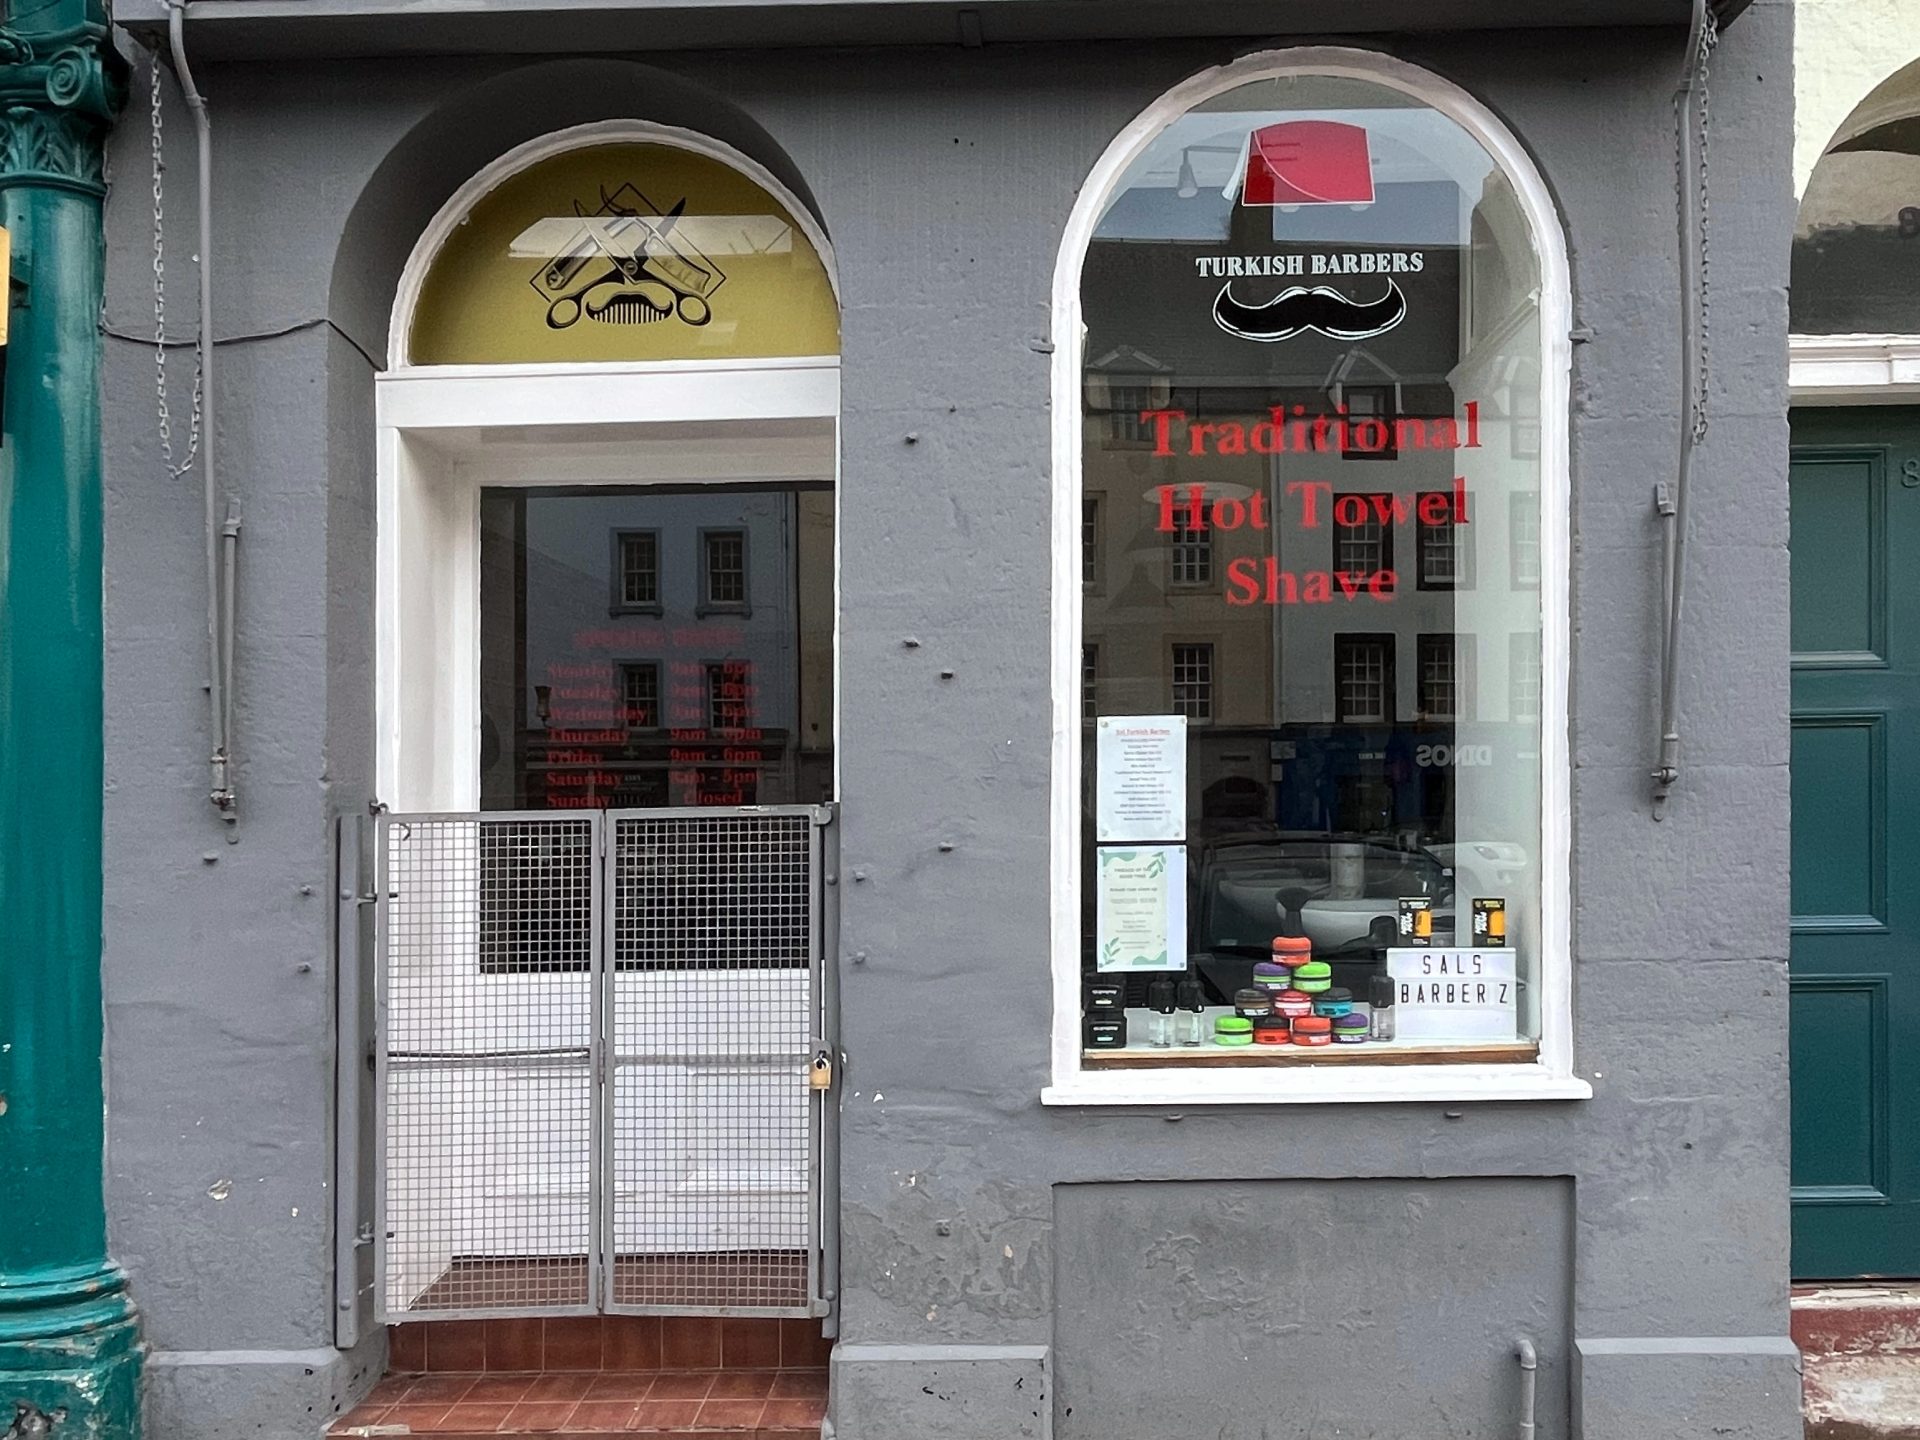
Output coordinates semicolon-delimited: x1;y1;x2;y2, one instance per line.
93;0;1797;1440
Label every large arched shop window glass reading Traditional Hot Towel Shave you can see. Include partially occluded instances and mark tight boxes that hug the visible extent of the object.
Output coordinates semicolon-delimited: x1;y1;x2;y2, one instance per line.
1081;77;1542;1060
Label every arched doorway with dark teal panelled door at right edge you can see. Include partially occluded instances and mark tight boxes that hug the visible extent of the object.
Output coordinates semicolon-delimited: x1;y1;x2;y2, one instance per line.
1791;61;1920;1279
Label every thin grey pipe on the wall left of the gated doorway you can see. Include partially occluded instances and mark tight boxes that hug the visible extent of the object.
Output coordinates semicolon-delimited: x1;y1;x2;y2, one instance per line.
167;0;240;824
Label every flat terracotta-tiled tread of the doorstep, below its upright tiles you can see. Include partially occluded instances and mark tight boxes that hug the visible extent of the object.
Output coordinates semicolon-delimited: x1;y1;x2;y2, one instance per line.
328;1369;828;1440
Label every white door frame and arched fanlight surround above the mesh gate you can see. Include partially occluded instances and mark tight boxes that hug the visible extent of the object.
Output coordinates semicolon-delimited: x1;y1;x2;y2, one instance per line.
374;119;843;812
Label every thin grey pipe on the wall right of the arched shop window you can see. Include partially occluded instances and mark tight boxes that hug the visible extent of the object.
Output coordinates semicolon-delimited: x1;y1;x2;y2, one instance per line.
1653;0;1718;820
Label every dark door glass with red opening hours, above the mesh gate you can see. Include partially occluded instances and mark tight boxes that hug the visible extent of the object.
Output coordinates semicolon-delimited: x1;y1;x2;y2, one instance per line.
480;486;833;810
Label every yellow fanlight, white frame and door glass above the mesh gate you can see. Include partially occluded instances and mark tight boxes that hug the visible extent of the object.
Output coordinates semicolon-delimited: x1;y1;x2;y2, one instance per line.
374;119;839;810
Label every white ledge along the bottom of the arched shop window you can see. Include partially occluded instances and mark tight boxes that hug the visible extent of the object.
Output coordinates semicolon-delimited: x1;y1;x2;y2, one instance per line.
1041;1066;1594;1106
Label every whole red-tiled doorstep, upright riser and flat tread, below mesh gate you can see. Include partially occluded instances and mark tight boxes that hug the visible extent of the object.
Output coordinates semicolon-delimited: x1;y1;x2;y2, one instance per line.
328;1315;831;1440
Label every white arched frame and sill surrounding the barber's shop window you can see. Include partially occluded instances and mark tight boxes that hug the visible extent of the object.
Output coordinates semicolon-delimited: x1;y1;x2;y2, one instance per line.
1041;46;1594;1106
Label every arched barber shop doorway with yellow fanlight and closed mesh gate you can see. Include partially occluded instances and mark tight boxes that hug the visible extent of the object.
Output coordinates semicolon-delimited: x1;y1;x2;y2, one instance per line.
374;121;839;1321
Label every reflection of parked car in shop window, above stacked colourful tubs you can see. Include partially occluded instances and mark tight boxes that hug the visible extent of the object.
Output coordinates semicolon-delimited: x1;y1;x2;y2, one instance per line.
1188;833;1453;995
